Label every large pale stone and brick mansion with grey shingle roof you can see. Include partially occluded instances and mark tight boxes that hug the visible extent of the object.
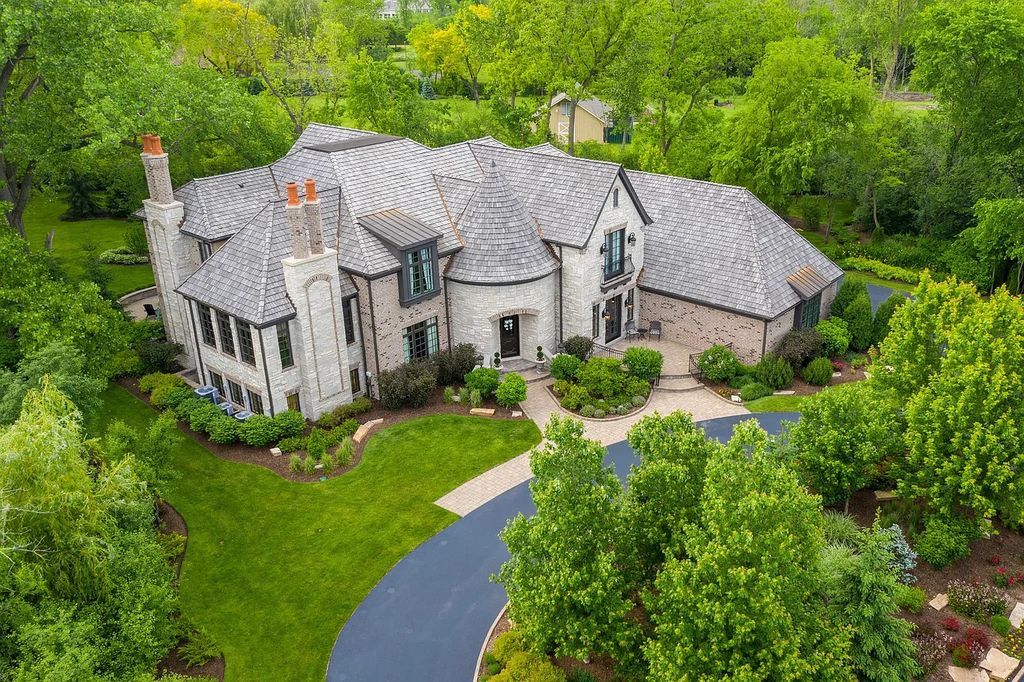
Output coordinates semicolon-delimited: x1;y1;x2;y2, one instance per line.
142;124;842;419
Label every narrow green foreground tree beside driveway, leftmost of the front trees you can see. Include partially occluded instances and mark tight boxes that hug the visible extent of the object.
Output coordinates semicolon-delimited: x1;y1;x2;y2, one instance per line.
498;417;639;658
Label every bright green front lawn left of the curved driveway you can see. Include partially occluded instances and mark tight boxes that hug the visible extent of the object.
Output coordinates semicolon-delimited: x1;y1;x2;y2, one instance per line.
98;386;541;681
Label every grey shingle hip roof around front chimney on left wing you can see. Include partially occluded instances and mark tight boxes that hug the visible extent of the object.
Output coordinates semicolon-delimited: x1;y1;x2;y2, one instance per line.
177;184;355;327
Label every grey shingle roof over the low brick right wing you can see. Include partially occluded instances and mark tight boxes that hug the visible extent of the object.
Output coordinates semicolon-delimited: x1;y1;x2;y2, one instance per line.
629;171;843;319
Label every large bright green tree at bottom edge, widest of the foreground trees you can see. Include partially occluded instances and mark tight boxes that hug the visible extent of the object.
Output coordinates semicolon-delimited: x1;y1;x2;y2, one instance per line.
644;423;852;681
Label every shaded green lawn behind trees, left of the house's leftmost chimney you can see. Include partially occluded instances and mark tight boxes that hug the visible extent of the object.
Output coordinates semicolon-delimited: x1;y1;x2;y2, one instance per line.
25;192;154;296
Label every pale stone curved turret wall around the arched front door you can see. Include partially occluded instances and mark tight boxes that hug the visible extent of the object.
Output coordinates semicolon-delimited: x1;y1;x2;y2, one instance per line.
447;272;558;359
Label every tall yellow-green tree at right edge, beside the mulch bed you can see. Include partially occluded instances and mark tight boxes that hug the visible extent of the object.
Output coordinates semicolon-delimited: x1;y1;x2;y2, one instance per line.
901;289;1024;525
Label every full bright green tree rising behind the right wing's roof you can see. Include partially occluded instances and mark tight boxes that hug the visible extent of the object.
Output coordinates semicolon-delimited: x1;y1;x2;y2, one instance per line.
712;38;873;206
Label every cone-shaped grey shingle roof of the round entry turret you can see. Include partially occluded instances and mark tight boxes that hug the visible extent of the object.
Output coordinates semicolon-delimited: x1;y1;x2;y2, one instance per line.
444;162;559;285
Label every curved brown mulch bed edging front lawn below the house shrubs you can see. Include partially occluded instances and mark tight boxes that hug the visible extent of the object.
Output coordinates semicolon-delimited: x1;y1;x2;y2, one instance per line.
118;379;527;483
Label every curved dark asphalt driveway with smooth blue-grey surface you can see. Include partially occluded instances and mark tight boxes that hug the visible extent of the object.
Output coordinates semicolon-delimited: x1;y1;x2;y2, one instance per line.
327;413;799;682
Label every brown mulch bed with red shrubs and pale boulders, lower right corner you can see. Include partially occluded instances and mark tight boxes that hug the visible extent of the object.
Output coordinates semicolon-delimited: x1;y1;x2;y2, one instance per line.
838;491;1024;682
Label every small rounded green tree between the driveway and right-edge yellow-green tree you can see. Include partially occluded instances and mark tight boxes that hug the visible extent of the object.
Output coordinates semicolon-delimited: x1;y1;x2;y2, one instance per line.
790;382;901;505
